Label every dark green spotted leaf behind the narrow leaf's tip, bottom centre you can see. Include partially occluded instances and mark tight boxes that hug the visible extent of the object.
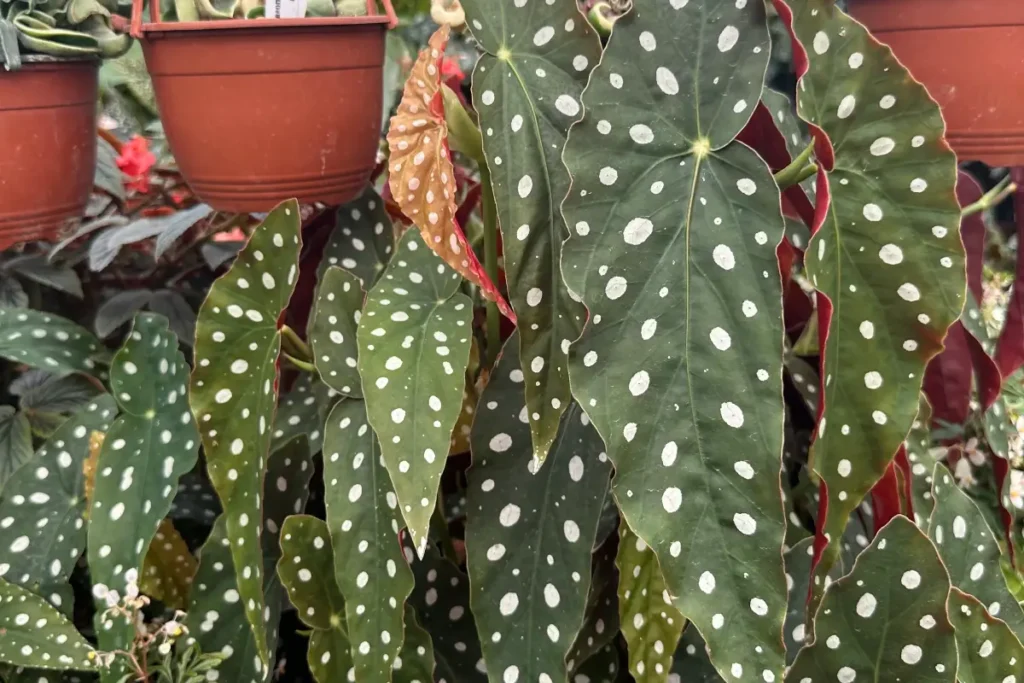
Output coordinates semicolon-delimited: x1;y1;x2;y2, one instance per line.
466;336;610;681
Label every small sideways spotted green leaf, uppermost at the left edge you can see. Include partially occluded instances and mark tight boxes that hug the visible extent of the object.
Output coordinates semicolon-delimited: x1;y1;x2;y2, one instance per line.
0;308;103;376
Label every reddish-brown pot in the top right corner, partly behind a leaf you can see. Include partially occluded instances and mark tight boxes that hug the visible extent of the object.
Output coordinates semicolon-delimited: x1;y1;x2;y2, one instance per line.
849;0;1024;166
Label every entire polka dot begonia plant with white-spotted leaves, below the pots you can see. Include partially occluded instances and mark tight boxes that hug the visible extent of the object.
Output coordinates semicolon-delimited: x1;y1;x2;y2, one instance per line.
0;0;1024;683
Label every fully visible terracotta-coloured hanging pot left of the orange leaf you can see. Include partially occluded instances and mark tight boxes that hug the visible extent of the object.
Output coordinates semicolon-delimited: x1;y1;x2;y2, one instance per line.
132;0;397;212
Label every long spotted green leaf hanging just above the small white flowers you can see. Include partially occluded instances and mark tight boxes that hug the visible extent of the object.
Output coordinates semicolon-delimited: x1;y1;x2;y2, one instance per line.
88;313;199;650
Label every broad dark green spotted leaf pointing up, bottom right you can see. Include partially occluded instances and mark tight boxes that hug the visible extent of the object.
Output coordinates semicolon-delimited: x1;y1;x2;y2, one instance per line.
785;516;956;683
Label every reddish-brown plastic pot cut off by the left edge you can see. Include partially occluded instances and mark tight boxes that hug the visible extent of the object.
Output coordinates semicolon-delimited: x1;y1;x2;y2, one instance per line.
0;57;99;251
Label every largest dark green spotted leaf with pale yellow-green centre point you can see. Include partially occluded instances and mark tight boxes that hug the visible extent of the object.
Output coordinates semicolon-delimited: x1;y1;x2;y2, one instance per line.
562;0;786;676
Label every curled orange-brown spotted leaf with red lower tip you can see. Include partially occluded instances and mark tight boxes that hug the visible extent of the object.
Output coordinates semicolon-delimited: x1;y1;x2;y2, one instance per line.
387;25;514;319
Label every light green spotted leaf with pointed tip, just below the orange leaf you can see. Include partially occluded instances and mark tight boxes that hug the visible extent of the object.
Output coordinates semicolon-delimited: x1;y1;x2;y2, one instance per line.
356;230;473;554
